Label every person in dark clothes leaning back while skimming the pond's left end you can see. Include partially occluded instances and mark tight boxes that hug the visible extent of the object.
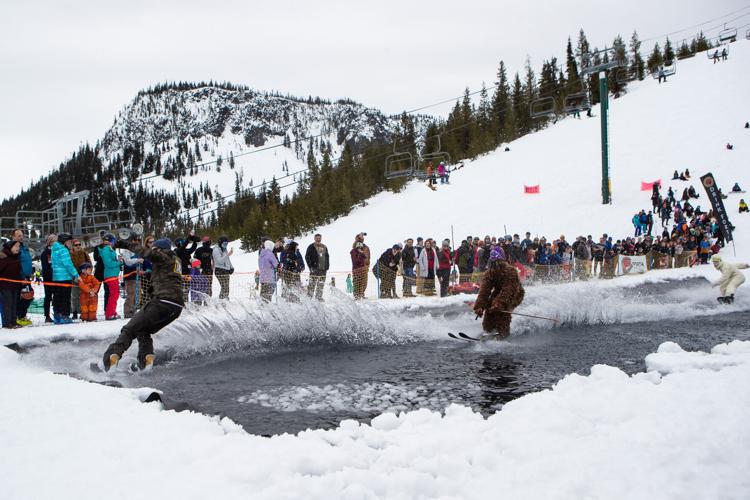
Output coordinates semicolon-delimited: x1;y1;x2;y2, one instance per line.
102;235;185;371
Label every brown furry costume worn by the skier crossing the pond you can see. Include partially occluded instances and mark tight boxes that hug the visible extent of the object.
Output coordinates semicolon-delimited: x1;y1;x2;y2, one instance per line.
474;261;524;339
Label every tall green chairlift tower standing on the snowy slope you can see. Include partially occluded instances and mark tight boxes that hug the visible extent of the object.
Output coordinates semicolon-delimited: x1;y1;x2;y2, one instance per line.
581;48;623;205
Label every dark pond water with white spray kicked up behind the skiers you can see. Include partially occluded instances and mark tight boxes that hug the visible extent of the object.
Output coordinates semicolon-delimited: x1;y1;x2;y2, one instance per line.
17;280;750;435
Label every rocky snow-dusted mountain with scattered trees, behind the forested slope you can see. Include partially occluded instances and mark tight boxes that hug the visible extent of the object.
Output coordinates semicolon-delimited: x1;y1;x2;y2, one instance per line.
0;83;432;229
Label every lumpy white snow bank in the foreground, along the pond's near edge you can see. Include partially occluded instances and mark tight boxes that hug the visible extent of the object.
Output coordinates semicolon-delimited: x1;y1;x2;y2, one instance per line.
0;341;750;500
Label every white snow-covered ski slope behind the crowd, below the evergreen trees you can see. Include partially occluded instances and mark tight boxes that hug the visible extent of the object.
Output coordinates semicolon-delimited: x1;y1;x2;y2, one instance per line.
236;40;750;271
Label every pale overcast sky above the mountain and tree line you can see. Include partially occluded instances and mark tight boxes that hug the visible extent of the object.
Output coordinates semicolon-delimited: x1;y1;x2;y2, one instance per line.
0;0;750;197
